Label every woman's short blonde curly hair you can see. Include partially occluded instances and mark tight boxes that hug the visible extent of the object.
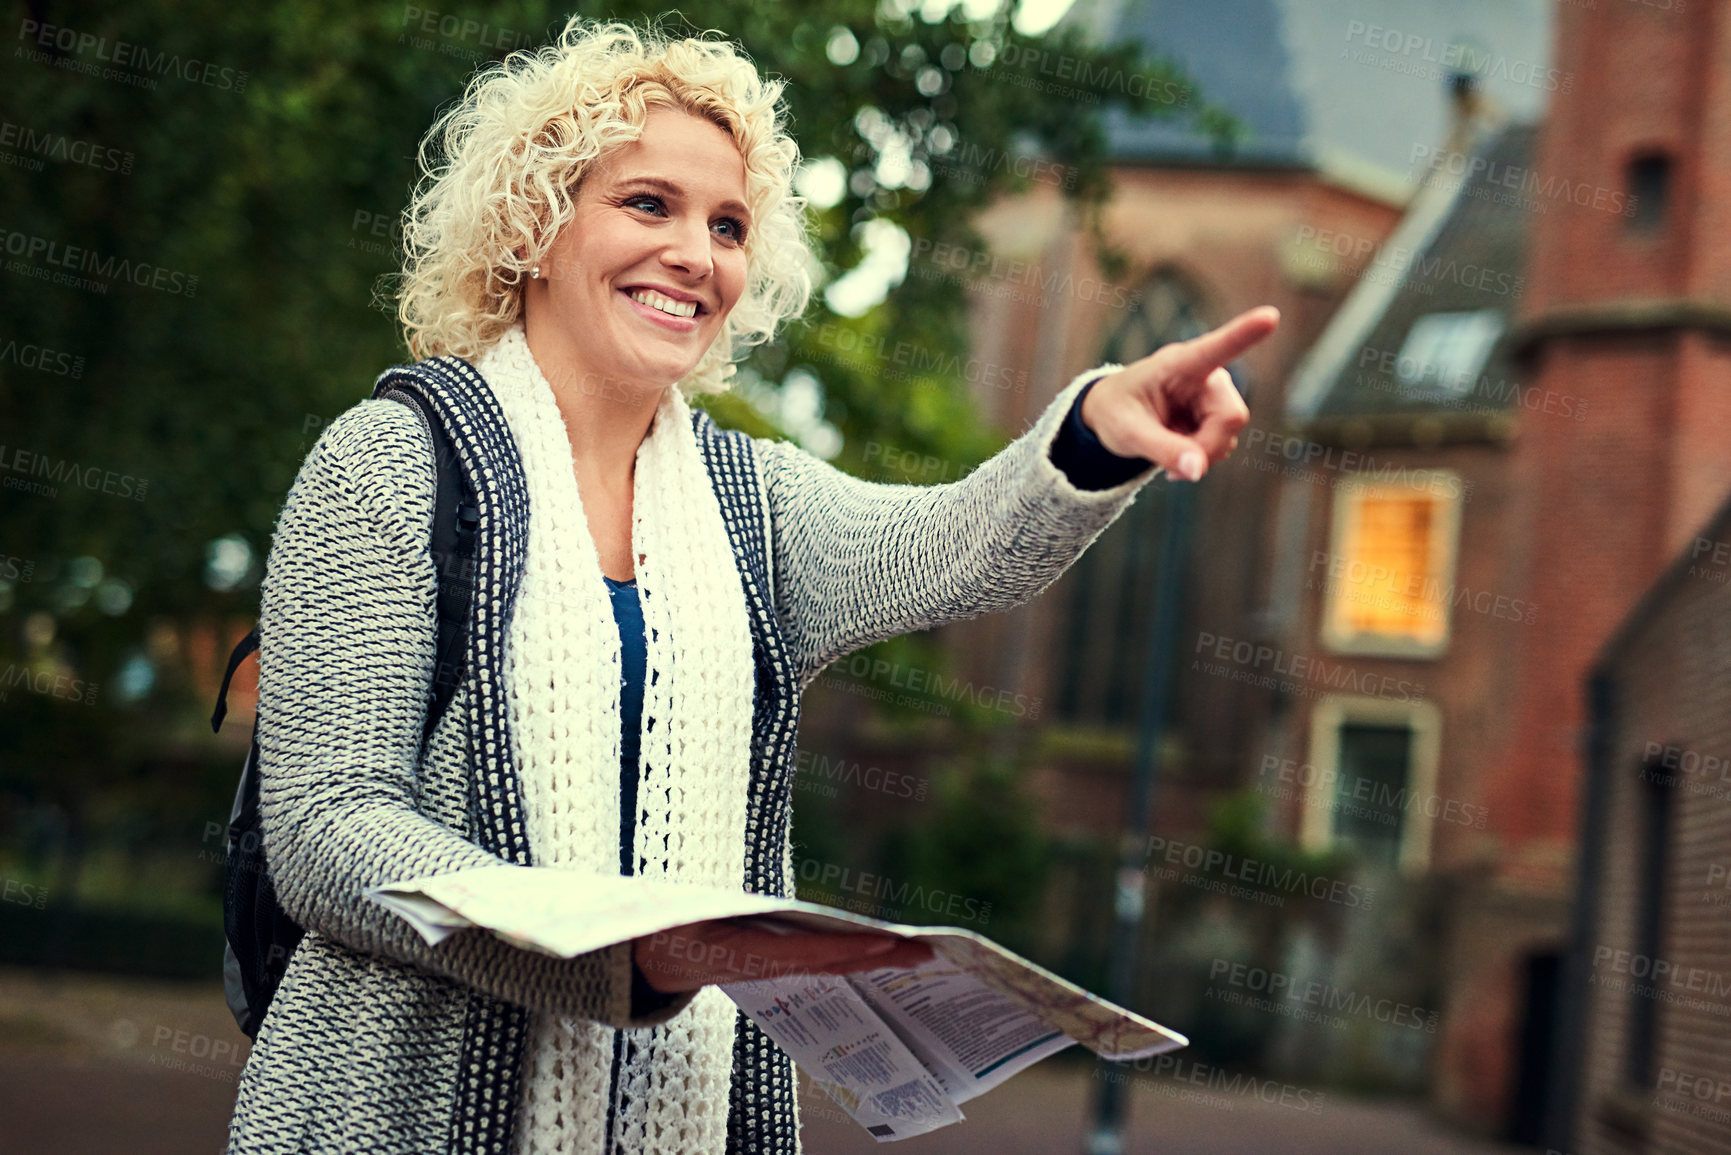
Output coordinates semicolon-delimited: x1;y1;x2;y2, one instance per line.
396;16;812;395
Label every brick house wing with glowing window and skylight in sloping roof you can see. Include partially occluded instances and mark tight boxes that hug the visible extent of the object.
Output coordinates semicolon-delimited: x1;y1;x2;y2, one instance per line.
1267;110;1550;1129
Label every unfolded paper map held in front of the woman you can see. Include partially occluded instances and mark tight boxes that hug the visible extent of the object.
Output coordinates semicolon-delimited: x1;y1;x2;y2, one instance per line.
367;864;1189;1143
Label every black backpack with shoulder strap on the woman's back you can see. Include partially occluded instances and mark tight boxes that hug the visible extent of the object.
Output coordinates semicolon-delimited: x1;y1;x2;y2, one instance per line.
211;379;479;1039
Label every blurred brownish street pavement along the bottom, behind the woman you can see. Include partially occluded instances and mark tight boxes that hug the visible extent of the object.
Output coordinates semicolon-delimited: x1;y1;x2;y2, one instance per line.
0;970;1532;1155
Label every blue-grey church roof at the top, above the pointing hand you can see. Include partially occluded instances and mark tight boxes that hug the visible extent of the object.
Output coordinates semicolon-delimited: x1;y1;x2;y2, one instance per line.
1065;0;1563;199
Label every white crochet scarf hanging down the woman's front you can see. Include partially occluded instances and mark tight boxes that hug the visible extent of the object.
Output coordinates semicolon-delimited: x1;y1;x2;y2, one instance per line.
476;324;753;1155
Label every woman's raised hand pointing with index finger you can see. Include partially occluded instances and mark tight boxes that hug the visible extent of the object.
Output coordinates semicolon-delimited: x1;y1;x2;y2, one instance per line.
1082;305;1281;481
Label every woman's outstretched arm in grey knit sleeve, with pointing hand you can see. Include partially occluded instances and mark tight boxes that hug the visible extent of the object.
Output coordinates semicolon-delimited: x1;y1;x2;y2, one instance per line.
756;308;1279;686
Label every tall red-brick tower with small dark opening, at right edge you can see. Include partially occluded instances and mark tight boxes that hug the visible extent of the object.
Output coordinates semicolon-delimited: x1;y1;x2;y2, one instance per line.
1502;2;1731;1150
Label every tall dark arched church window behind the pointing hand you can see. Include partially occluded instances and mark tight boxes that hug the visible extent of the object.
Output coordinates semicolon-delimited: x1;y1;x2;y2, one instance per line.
1054;268;1208;727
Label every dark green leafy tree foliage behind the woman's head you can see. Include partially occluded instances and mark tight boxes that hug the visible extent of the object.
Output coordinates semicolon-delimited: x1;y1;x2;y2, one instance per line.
0;0;1213;914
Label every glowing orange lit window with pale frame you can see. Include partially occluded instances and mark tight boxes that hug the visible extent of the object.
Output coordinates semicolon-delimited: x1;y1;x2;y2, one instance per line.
1307;469;1461;658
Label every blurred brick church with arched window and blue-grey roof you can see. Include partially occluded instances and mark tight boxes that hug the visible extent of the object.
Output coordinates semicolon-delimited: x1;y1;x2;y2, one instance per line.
808;0;1551;848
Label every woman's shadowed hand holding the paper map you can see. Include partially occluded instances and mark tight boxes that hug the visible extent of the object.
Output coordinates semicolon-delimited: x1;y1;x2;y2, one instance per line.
632;918;931;994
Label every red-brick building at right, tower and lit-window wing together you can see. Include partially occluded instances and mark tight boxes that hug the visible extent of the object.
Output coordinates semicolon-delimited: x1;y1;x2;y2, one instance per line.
1269;5;1731;1139
